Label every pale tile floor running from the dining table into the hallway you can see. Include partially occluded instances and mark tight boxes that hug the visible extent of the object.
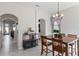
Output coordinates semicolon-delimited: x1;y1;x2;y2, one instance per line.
0;36;77;56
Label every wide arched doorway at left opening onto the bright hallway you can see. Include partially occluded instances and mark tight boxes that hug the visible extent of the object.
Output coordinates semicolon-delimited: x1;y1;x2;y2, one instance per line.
0;14;18;50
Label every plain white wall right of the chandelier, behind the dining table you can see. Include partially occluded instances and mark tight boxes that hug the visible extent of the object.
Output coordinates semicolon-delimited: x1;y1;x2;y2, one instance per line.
61;6;79;34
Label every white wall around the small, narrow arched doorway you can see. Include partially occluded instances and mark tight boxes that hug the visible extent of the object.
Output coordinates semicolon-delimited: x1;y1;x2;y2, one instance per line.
37;7;51;35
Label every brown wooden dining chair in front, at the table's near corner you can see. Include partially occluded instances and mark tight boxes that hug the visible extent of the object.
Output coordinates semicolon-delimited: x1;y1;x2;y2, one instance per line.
52;37;66;56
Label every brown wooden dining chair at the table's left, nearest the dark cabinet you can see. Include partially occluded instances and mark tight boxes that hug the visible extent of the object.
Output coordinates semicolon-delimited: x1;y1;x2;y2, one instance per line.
41;36;52;56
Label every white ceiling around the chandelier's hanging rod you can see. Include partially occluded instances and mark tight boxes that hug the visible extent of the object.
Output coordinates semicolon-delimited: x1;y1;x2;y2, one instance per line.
32;2;79;13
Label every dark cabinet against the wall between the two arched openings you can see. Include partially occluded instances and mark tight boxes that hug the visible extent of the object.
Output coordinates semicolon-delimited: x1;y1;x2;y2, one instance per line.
23;33;38;49
